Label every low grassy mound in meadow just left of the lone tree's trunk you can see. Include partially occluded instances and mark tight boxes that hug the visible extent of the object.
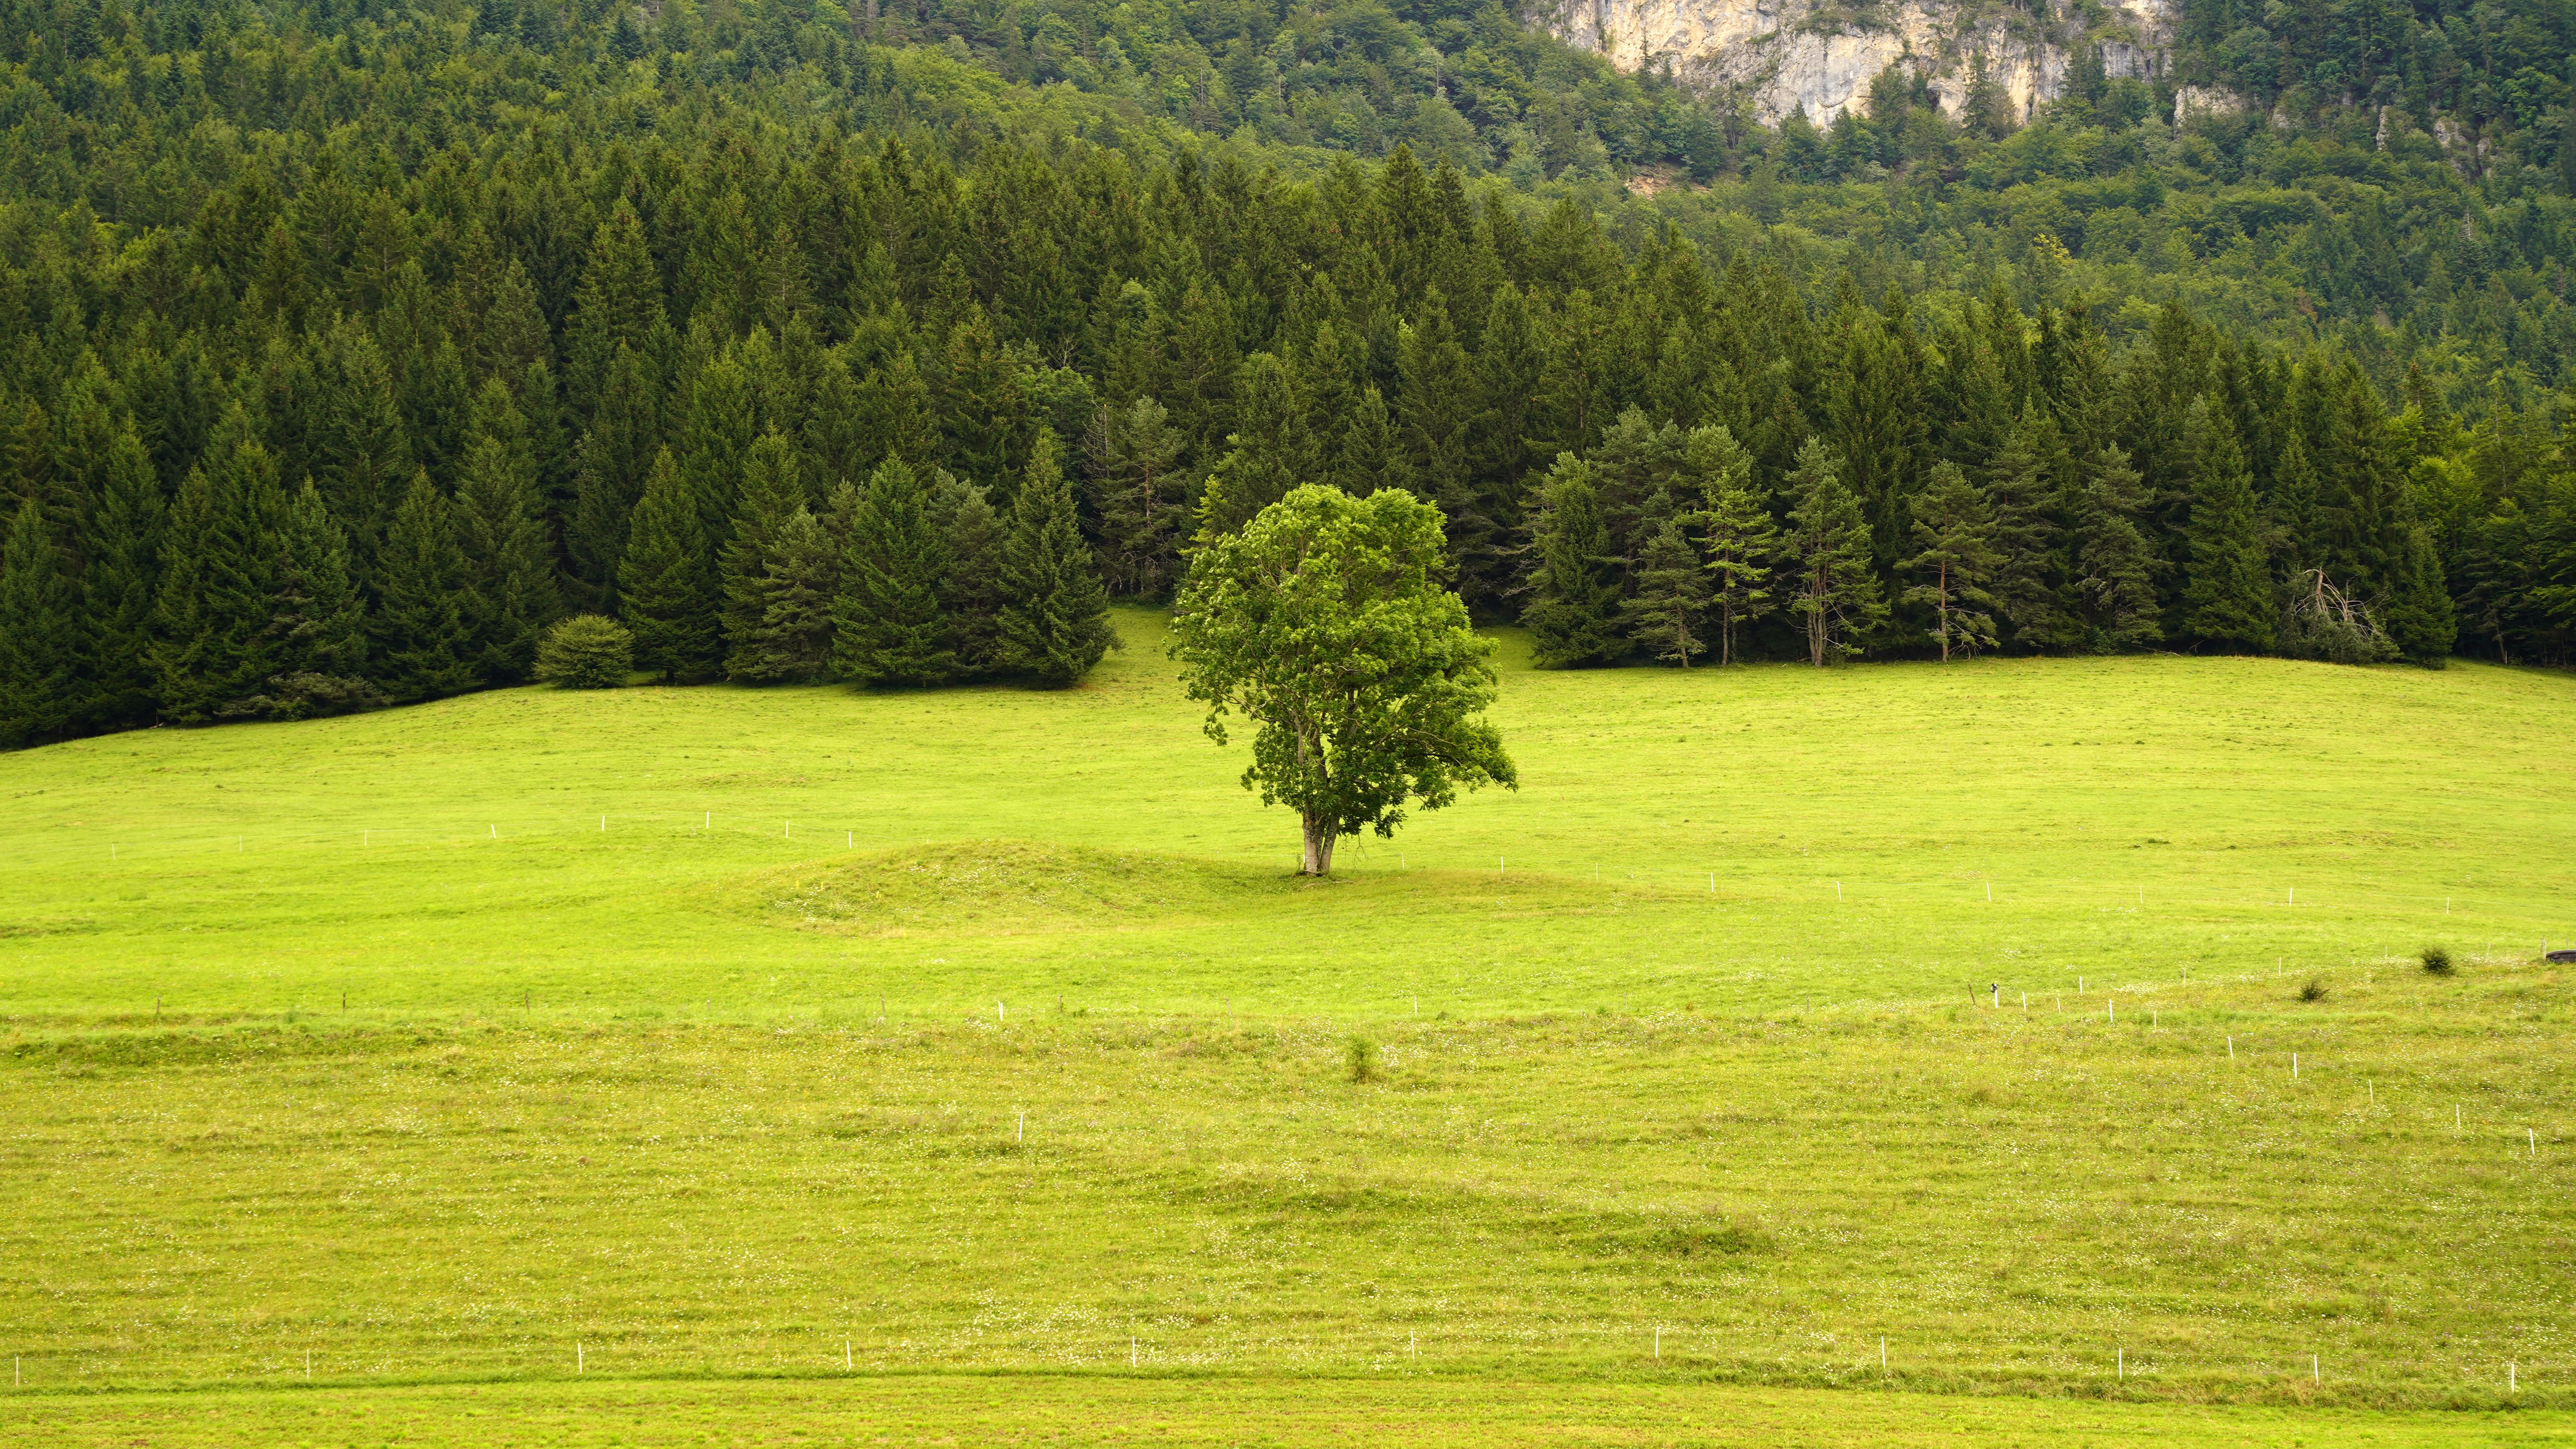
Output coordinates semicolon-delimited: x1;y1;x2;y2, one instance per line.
734;842;1265;937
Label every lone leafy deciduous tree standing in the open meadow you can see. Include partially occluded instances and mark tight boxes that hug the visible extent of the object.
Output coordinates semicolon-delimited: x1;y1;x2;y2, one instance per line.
1172;486;1520;875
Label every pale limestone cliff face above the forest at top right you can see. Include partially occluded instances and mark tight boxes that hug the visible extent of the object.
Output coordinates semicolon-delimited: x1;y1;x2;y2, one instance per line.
1530;0;2182;126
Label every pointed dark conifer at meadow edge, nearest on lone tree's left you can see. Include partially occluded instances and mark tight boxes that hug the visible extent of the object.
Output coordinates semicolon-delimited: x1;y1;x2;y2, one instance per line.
997;427;1115;690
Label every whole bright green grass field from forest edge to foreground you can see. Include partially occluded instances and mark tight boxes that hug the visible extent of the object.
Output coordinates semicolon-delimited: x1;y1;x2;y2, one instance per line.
0;612;2576;1444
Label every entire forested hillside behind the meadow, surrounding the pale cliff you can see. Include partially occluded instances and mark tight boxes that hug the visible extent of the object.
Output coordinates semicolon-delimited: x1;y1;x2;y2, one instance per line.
0;0;2576;744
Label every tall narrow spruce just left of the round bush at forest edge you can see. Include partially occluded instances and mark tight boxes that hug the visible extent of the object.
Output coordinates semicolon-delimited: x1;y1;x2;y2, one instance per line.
456;378;564;685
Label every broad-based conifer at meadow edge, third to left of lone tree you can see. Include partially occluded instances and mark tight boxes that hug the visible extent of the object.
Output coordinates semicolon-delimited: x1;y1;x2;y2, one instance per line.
832;458;958;685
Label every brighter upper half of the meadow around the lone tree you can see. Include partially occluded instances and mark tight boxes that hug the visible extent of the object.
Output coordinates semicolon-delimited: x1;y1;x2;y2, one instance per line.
0;612;2576;1027
